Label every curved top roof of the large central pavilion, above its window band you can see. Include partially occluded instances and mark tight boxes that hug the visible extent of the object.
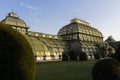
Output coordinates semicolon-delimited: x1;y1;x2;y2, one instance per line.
58;18;103;37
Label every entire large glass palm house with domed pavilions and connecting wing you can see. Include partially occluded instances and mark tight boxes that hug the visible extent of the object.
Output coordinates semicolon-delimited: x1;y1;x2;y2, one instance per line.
1;12;113;61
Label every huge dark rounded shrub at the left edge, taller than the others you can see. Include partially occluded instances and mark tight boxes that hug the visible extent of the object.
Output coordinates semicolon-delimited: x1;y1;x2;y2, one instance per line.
0;23;35;80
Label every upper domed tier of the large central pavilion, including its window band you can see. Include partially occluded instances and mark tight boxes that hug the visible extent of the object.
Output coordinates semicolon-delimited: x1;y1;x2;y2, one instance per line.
58;18;103;42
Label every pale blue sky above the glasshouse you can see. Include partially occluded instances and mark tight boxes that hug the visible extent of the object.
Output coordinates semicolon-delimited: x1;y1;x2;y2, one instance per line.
0;0;120;40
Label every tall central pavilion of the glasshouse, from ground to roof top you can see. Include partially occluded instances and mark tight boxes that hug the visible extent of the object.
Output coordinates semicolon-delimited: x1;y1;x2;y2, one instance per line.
58;18;103;60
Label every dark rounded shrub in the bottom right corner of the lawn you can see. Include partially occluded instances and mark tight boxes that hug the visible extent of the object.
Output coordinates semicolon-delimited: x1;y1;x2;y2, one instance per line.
92;59;120;80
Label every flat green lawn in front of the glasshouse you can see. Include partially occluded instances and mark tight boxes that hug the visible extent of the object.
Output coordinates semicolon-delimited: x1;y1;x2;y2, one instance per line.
36;61;96;80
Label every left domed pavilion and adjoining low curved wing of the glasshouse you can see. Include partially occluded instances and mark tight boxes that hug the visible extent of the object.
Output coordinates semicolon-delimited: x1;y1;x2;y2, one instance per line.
1;12;67;61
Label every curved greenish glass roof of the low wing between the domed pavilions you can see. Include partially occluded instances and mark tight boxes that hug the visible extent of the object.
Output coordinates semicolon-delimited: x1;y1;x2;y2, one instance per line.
24;35;65;56
